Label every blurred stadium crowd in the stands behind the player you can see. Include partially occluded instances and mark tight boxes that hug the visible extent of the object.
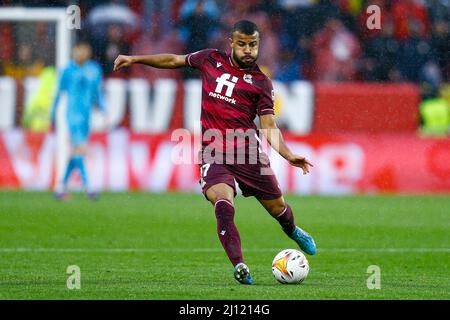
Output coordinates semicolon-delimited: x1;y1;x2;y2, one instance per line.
0;0;450;134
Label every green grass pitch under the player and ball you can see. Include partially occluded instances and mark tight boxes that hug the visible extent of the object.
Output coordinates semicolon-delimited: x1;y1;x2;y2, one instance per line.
0;192;450;300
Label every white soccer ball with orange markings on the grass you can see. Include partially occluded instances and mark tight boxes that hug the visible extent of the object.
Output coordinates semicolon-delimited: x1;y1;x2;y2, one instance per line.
272;249;309;284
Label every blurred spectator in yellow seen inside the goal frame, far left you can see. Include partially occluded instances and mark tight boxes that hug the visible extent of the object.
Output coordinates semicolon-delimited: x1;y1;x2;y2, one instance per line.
3;43;44;79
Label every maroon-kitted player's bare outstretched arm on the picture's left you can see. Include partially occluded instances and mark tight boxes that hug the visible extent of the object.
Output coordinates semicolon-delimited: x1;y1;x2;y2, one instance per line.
114;53;186;71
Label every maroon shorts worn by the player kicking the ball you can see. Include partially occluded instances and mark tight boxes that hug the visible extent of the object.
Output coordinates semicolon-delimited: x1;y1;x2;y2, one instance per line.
200;163;282;200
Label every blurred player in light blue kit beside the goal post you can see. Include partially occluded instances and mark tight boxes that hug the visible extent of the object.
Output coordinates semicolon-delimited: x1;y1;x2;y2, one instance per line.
51;42;106;200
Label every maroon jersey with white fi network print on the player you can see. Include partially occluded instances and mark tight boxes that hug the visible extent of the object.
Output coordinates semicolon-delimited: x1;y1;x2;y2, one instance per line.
186;49;274;160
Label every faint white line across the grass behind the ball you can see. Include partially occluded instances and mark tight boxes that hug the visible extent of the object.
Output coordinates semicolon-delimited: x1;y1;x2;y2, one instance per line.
0;248;450;253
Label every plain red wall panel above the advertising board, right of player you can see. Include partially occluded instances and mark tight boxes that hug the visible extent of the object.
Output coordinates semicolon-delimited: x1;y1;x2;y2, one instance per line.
313;83;420;133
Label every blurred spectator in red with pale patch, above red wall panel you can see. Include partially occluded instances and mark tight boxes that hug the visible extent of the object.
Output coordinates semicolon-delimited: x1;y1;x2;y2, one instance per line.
311;17;360;81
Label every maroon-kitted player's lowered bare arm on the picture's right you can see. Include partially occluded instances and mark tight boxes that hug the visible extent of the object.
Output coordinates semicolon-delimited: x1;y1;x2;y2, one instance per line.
259;114;313;174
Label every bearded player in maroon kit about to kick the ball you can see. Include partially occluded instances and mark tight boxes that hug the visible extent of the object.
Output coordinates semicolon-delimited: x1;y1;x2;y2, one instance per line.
114;20;316;284
